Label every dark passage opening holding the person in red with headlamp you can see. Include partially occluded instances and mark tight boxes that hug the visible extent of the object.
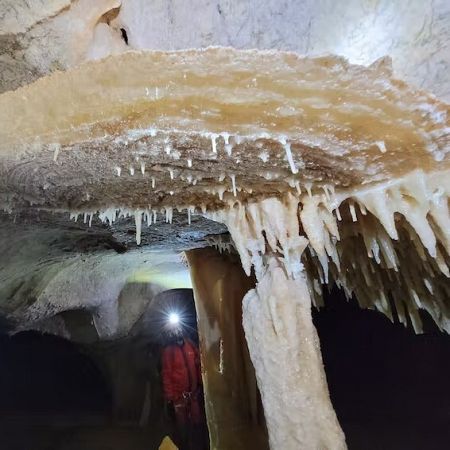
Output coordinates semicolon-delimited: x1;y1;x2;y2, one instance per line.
140;289;209;450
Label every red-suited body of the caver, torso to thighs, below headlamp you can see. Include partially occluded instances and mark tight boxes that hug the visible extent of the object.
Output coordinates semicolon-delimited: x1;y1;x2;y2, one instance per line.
161;339;202;424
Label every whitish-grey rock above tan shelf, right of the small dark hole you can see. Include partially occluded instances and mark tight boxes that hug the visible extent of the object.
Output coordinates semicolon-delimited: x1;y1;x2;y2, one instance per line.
118;0;450;99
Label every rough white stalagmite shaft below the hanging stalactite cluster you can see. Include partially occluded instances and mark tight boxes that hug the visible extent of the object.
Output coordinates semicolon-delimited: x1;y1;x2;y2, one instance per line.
243;255;346;450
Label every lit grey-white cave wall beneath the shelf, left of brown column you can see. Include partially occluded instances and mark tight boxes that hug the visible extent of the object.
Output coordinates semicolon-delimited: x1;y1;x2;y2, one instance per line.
0;216;190;341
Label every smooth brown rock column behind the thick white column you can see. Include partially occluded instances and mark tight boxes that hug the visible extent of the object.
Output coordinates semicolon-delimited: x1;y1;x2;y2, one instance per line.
186;248;268;450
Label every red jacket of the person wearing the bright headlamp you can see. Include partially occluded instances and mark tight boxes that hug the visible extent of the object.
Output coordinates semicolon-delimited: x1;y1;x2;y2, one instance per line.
161;339;202;402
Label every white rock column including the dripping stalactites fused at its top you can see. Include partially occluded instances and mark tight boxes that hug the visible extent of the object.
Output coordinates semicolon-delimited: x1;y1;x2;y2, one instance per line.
209;196;346;450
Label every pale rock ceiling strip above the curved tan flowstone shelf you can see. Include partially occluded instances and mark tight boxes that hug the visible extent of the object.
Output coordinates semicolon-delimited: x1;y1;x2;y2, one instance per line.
0;0;450;100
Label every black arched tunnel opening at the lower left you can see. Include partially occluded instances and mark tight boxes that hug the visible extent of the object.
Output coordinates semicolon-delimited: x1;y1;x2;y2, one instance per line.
0;331;111;418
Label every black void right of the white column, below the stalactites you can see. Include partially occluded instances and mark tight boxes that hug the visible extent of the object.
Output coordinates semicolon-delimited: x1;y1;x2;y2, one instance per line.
313;289;450;450
